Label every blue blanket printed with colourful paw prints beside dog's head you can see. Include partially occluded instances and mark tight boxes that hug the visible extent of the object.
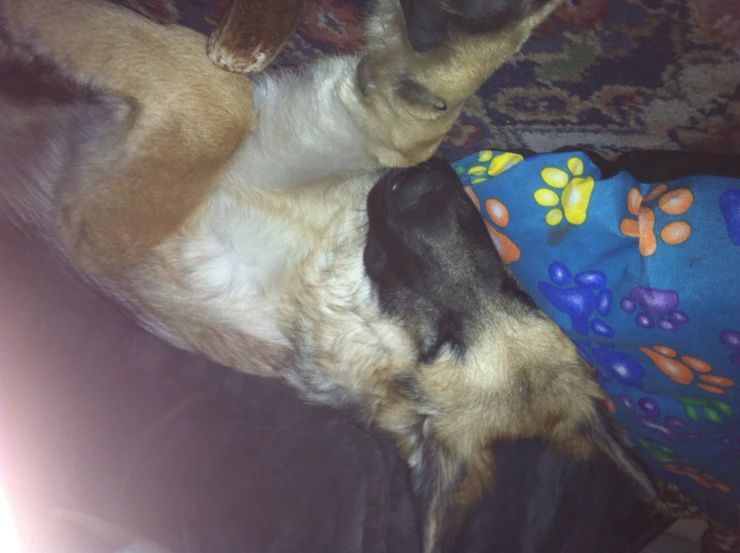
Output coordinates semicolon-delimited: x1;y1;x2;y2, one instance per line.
453;150;740;534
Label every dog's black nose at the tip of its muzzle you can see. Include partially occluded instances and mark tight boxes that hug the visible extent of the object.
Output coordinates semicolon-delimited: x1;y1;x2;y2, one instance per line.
388;158;458;211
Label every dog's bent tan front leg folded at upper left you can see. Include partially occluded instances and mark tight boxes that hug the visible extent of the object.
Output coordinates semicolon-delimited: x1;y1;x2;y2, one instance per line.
3;0;254;271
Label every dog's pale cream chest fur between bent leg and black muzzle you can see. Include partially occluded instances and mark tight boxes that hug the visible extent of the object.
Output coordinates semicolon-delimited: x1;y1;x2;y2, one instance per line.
135;159;396;375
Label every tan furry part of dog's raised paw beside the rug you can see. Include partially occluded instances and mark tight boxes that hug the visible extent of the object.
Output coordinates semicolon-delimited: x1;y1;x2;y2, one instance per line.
357;0;560;166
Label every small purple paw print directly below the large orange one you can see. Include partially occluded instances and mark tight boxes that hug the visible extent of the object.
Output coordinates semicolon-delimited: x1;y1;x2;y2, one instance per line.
621;286;689;332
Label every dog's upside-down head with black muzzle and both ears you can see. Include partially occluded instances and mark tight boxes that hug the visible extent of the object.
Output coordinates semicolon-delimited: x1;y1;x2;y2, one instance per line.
363;159;649;553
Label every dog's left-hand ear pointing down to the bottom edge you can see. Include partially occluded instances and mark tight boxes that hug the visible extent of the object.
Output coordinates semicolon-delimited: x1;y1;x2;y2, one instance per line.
409;417;493;553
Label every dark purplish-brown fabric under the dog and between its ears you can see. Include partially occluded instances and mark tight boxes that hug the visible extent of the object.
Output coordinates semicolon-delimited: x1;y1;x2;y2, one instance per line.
0;218;648;553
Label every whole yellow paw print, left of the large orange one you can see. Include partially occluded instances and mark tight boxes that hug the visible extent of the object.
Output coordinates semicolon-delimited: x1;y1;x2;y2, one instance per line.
534;157;596;227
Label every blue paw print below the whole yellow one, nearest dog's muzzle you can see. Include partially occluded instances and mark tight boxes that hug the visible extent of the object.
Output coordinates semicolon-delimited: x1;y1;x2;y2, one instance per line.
538;261;614;338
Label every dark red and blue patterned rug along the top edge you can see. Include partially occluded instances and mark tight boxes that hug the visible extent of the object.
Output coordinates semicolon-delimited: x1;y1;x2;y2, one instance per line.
123;0;740;159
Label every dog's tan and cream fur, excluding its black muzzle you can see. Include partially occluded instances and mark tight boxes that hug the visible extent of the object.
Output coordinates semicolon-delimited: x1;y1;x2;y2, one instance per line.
0;0;652;553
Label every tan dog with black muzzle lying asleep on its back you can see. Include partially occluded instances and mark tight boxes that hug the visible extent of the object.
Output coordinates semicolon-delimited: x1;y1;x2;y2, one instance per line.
0;0;651;553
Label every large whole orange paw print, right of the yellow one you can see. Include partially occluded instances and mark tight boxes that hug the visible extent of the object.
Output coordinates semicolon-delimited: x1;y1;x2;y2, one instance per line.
619;184;694;256
